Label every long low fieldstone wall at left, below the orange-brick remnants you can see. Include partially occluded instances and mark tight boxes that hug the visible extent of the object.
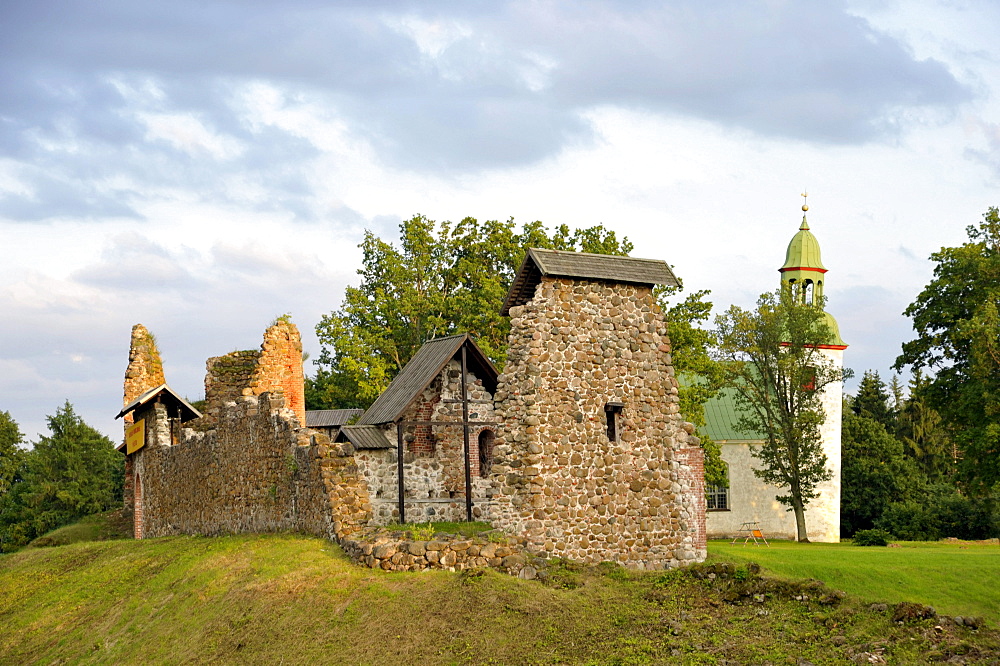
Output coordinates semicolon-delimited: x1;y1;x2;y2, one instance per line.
130;394;371;539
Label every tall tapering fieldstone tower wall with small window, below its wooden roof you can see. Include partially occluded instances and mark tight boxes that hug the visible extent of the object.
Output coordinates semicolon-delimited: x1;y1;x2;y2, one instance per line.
492;277;705;569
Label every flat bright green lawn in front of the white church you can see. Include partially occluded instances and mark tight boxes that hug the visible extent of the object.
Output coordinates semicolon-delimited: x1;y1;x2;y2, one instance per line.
708;541;1000;621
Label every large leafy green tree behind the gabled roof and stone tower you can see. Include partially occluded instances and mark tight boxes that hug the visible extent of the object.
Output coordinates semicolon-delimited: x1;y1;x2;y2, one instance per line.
306;215;725;483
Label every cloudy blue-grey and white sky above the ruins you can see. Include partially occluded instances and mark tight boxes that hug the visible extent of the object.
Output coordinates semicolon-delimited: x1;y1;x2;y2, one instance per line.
0;0;1000;439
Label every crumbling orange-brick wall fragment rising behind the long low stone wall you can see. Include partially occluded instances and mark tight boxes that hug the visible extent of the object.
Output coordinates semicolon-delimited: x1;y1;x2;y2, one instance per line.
195;318;306;431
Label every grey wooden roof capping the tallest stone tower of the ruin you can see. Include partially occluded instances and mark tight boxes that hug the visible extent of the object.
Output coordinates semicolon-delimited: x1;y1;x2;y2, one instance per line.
500;247;679;316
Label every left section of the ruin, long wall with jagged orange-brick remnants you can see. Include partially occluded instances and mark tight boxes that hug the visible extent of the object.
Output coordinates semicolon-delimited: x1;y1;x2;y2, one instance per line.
124;318;371;539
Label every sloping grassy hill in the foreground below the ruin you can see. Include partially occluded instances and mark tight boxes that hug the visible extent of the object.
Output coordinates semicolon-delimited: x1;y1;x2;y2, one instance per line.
0;535;1000;665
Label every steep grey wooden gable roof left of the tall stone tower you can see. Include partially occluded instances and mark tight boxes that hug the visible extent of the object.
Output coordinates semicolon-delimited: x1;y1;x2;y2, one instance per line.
358;333;499;425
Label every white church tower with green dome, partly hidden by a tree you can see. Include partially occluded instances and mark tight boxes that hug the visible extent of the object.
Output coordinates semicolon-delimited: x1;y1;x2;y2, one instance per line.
778;204;847;543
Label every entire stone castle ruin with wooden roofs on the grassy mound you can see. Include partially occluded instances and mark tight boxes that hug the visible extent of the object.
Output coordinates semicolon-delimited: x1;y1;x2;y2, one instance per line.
119;249;705;574
